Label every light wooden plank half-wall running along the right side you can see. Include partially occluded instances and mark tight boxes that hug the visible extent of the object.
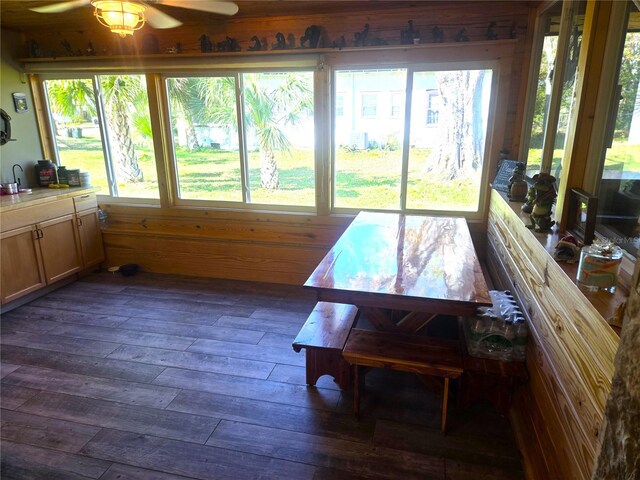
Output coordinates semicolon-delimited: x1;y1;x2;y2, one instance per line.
487;191;618;480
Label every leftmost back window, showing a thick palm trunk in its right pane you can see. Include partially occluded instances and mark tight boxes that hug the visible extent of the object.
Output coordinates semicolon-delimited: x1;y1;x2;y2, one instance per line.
44;75;159;199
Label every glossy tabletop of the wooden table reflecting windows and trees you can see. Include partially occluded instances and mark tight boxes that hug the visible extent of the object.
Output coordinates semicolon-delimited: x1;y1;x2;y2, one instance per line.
305;212;490;306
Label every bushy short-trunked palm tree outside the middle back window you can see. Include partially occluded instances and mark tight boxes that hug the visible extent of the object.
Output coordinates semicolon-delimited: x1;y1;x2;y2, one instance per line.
203;73;313;190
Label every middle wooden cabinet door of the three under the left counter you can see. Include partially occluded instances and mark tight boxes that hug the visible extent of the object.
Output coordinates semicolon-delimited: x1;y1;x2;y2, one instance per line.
38;214;82;283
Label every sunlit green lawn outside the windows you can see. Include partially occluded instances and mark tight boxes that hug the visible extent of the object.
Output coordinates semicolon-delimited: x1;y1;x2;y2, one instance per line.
58;137;640;211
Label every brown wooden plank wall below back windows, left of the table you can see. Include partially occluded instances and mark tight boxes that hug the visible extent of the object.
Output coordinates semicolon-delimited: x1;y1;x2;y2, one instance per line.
102;205;352;285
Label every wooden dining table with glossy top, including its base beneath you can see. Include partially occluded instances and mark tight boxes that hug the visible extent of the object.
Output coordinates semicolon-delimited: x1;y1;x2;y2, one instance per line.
304;212;491;333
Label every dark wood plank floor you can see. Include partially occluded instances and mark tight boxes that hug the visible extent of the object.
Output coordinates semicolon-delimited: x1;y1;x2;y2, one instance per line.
0;273;523;480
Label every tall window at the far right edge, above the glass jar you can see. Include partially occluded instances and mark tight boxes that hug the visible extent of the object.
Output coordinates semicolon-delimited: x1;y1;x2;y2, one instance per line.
596;2;640;255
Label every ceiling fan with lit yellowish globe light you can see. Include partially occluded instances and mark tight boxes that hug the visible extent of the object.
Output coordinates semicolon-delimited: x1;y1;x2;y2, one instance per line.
30;0;238;37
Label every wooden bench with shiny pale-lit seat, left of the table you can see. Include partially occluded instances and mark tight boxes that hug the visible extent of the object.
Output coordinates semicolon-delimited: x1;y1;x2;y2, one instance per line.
292;302;358;390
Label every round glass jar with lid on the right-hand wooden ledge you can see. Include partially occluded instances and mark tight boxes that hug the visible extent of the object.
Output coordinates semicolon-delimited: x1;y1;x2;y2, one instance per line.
577;241;622;293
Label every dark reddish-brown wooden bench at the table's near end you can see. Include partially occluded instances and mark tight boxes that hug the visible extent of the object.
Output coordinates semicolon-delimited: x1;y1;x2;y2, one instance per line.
342;328;462;433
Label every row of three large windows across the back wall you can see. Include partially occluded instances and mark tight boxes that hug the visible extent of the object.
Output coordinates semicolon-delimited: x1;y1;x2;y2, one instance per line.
37;50;500;216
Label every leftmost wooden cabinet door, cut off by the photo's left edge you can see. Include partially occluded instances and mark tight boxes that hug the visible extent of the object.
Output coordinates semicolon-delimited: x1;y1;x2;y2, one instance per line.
0;225;46;304
